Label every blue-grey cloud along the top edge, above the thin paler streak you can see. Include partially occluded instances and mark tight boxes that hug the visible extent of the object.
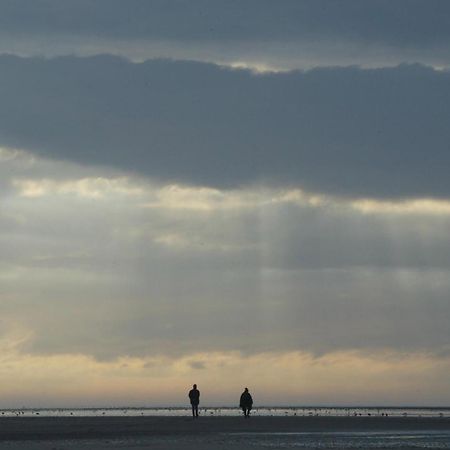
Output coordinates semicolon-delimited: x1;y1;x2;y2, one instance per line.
0;0;450;45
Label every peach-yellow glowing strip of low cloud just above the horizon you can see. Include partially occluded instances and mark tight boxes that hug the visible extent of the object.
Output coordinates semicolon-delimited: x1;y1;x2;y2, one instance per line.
0;349;450;406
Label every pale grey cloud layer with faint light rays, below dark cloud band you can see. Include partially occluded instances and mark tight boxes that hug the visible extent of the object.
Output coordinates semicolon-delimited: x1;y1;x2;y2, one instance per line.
0;152;450;360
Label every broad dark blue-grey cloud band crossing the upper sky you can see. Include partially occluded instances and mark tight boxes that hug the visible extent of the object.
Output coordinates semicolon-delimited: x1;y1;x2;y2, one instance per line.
0;56;450;198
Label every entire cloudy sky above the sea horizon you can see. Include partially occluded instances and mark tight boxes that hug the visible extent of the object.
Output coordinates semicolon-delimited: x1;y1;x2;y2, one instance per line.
0;0;450;408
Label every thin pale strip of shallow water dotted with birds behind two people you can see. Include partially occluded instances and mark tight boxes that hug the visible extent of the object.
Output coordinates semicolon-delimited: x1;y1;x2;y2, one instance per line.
0;407;450;417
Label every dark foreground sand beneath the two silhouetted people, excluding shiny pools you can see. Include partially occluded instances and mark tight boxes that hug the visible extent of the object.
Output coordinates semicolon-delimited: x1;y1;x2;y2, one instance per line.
0;416;450;450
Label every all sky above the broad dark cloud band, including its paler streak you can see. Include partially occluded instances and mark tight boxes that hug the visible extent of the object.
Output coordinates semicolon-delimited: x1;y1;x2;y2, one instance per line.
0;0;450;70
